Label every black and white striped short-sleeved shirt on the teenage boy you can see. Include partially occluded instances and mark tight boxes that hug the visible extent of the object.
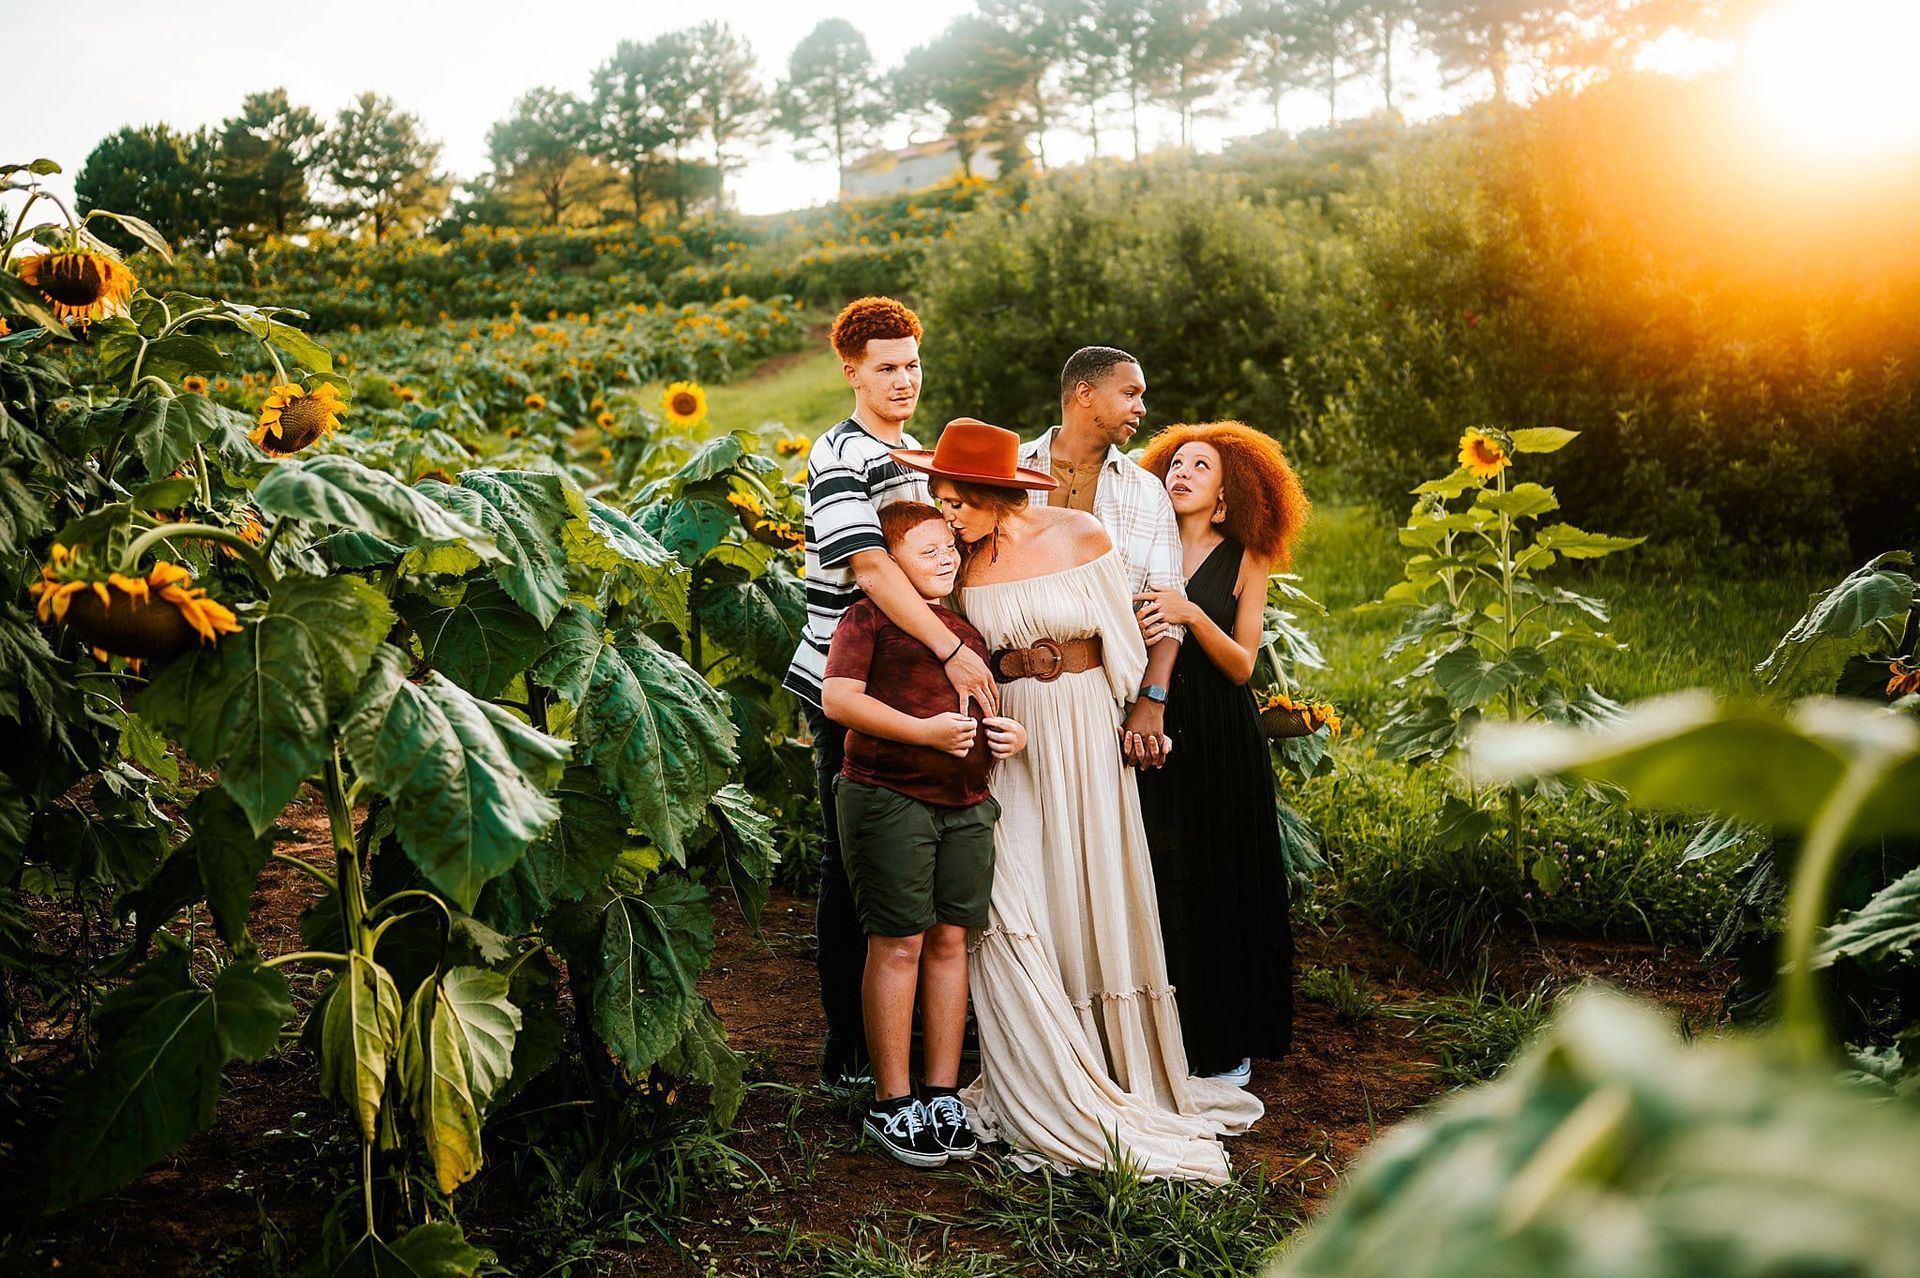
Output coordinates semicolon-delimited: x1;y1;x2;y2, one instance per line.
785;416;931;706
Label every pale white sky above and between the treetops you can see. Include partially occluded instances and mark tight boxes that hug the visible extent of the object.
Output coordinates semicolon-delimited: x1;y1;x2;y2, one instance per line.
0;0;1457;213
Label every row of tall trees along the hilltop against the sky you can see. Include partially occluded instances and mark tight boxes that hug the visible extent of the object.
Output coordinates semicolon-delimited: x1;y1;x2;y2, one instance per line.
75;0;1753;239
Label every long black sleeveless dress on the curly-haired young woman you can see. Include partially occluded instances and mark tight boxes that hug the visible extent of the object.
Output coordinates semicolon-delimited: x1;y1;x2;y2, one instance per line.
1139;537;1294;1075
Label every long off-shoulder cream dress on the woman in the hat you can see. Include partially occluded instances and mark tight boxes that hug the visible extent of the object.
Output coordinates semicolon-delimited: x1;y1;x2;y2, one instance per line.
958;551;1261;1182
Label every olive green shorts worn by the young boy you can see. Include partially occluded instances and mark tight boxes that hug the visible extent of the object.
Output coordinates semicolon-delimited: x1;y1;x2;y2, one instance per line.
833;777;1000;936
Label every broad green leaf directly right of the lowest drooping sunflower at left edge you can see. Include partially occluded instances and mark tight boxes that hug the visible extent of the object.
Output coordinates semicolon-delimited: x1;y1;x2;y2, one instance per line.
134;578;394;835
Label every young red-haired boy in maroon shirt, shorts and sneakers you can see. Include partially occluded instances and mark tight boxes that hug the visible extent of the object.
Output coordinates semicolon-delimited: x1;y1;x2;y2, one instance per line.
822;501;1027;1167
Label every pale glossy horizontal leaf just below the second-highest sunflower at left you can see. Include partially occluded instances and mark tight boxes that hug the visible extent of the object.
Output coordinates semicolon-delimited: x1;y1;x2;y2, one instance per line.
253;453;505;562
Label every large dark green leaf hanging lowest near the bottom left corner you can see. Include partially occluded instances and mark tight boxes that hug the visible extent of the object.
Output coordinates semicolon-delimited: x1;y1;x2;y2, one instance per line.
50;946;294;1207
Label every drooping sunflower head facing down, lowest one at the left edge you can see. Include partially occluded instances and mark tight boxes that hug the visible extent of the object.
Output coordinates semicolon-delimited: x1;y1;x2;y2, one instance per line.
27;545;240;660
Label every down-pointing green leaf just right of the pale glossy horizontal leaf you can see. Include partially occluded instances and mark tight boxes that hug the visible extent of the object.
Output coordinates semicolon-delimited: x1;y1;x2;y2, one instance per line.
419;470;568;627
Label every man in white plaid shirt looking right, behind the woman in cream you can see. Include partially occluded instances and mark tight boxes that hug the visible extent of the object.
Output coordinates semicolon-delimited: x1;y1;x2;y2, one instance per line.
1020;345;1187;768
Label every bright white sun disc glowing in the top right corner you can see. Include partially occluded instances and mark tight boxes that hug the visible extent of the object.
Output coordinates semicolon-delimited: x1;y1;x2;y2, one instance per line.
1743;0;1920;157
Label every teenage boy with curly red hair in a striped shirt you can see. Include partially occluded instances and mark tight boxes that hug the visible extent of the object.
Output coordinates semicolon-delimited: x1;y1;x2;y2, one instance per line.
783;297;1000;1096
